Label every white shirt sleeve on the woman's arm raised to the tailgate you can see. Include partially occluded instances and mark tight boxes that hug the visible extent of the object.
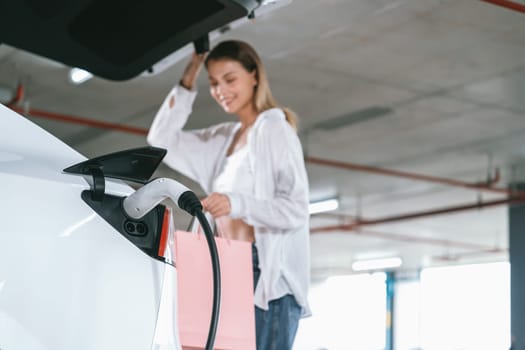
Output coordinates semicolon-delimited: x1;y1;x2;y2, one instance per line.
147;85;227;189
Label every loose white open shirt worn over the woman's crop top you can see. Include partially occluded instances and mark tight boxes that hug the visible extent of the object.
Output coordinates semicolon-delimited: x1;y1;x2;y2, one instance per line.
148;85;310;317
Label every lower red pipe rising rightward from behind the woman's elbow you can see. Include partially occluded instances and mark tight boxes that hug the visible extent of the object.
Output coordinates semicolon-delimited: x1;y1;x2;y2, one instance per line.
310;197;525;233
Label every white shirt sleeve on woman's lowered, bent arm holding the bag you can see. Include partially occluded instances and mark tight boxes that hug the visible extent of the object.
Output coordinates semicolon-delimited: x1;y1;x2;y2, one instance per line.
227;121;309;231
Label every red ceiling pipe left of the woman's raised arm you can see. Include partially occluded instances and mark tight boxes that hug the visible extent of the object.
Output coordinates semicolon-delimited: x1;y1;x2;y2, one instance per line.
8;105;148;135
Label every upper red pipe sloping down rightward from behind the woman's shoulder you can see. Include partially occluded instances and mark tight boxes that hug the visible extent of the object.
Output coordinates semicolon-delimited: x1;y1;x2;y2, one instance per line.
305;157;525;197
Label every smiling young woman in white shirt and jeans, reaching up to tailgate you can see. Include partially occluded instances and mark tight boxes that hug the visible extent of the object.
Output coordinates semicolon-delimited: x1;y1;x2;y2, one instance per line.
148;41;310;350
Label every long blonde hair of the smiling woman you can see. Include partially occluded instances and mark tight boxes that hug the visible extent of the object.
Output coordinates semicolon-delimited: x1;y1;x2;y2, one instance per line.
204;40;297;130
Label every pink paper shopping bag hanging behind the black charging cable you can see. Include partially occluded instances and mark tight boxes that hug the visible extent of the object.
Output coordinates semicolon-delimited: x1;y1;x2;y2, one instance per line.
175;231;255;350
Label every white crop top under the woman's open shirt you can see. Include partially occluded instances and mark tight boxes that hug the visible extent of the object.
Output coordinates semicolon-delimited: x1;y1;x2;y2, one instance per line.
213;146;254;195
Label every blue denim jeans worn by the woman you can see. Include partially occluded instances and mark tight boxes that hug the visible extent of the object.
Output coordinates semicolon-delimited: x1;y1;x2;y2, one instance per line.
252;245;301;350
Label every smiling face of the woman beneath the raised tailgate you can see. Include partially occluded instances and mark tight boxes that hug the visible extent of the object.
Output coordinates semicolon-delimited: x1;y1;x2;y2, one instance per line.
208;59;257;114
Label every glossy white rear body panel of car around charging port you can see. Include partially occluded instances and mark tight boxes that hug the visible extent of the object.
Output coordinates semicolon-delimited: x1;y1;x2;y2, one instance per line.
0;100;184;350
